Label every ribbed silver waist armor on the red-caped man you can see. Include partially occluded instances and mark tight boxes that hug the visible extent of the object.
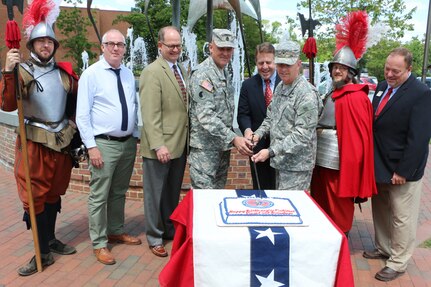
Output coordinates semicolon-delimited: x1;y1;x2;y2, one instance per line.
316;129;340;170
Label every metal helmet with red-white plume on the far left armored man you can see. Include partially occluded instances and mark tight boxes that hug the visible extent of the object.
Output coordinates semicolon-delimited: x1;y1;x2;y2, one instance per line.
23;0;61;52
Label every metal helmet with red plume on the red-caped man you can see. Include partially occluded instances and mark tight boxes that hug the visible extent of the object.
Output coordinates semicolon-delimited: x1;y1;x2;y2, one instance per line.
328;11;368;75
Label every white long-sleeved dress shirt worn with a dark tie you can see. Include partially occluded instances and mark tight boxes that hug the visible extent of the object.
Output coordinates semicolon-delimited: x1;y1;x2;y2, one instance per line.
76;59;138;148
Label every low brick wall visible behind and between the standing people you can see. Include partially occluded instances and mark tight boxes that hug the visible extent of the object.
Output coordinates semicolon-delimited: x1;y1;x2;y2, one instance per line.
0;123;252;200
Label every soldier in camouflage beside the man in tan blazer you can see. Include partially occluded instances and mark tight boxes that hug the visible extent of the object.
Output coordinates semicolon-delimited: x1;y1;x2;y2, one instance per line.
189;29;252;189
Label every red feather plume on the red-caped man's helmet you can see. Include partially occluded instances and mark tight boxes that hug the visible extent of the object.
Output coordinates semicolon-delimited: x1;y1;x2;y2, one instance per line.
335;11;368;59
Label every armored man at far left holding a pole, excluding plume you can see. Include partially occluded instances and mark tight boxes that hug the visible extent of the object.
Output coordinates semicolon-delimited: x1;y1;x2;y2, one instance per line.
0;22;78;276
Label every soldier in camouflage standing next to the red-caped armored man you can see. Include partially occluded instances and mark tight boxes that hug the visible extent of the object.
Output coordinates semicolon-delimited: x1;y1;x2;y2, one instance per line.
252;40;322;190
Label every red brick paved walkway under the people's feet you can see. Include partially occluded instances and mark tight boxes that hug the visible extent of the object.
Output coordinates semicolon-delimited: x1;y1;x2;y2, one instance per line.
0;161;431;287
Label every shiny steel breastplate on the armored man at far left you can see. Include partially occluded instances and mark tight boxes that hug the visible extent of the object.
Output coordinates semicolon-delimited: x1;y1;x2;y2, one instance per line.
22;63;67;132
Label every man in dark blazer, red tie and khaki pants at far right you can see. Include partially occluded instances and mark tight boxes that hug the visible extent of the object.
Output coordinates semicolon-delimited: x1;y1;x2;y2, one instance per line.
363;48;431;281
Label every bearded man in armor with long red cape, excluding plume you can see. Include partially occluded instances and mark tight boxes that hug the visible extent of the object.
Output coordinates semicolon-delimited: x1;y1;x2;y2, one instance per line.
311;11;376;235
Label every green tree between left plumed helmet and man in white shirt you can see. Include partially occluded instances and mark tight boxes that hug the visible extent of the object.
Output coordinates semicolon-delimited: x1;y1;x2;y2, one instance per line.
56;0;98;74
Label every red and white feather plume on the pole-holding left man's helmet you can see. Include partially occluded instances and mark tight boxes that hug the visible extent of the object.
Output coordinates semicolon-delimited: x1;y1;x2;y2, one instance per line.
22;0;55;38
